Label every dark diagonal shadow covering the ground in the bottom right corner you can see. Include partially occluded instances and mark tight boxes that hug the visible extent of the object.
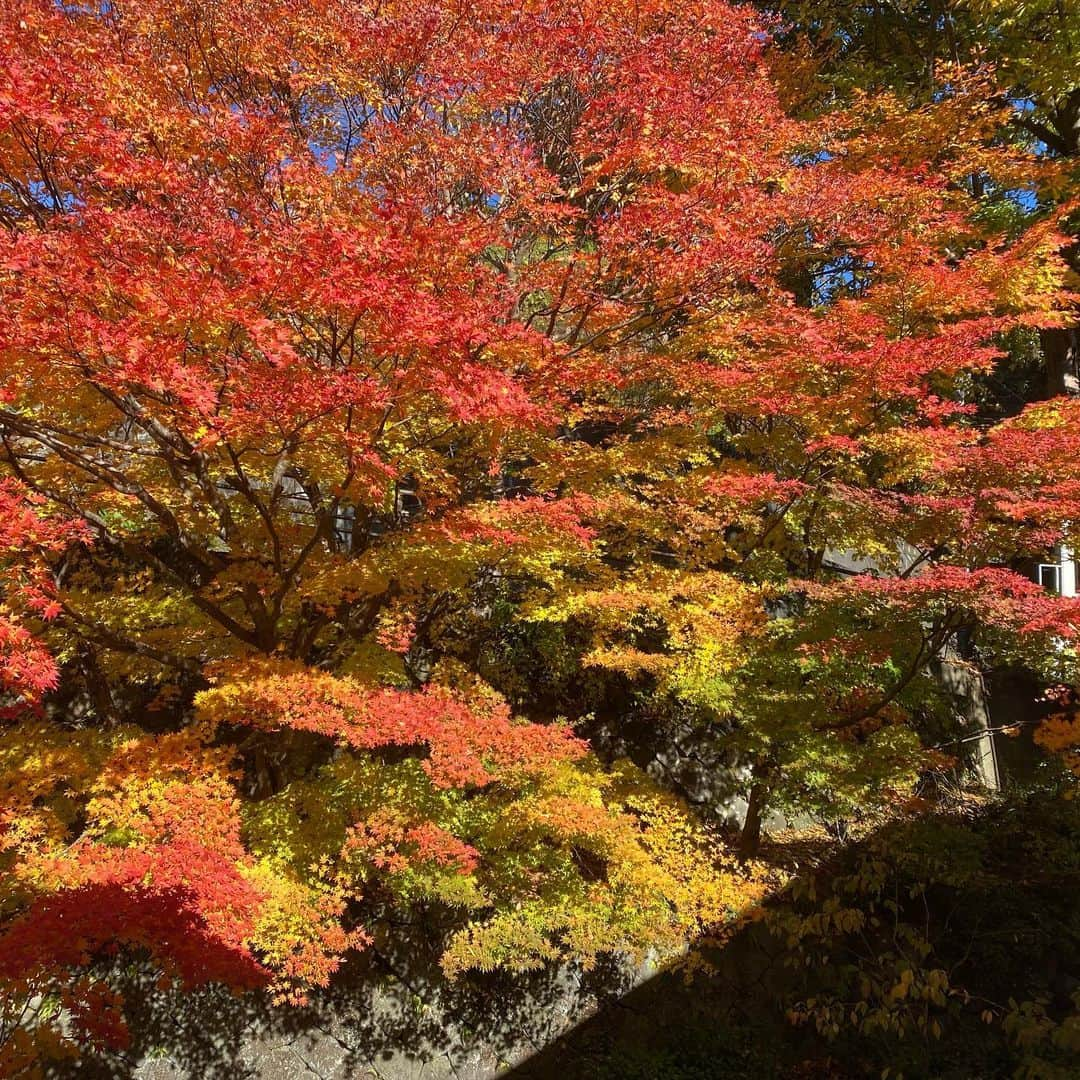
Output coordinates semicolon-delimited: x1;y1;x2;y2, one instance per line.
505;789;1080;1080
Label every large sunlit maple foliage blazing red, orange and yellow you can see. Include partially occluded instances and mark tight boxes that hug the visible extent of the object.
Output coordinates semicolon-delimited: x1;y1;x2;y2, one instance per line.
0;0;1080;1055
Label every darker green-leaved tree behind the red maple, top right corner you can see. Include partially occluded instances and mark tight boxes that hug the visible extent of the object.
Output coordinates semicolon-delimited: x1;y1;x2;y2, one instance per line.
759;0;1080;401
